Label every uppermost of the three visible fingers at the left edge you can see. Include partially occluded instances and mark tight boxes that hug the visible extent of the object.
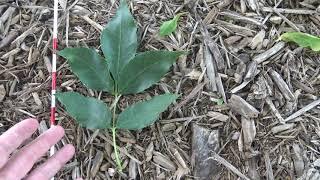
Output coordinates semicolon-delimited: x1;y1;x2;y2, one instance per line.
0;119;39;169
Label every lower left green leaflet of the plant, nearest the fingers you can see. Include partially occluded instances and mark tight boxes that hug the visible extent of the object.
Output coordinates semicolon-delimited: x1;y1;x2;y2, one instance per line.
56;92;112;129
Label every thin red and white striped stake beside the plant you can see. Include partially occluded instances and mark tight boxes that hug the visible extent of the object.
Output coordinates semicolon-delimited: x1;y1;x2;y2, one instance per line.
50;0;58;163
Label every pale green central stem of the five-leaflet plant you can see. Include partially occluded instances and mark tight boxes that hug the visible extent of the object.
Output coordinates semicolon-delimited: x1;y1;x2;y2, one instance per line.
111;94;122;172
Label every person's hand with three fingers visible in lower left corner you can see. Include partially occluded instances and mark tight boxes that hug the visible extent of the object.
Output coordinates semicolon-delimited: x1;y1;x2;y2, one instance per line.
0;119;75;180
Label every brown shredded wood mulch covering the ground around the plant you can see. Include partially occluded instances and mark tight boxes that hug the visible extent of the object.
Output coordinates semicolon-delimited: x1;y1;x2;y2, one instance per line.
0;0;320;180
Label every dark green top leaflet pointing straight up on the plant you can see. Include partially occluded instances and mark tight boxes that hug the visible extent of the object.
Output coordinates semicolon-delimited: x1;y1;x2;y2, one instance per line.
101;0;138;82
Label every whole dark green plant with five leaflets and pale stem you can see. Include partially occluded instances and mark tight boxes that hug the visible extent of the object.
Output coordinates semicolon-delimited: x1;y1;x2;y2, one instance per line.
56;0;183;171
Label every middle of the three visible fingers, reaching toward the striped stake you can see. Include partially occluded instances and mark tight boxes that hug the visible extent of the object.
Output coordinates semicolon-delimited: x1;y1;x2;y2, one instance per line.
0;126;64;179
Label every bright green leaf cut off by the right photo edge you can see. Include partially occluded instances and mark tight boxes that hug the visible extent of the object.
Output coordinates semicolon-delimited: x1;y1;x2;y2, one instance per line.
280;32;320;51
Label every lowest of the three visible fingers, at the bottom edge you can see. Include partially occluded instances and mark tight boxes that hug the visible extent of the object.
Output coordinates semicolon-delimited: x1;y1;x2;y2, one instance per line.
27;145;75;180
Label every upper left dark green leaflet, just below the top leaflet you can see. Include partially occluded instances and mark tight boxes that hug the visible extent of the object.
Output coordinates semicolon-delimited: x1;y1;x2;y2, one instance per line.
59;48;114;92
